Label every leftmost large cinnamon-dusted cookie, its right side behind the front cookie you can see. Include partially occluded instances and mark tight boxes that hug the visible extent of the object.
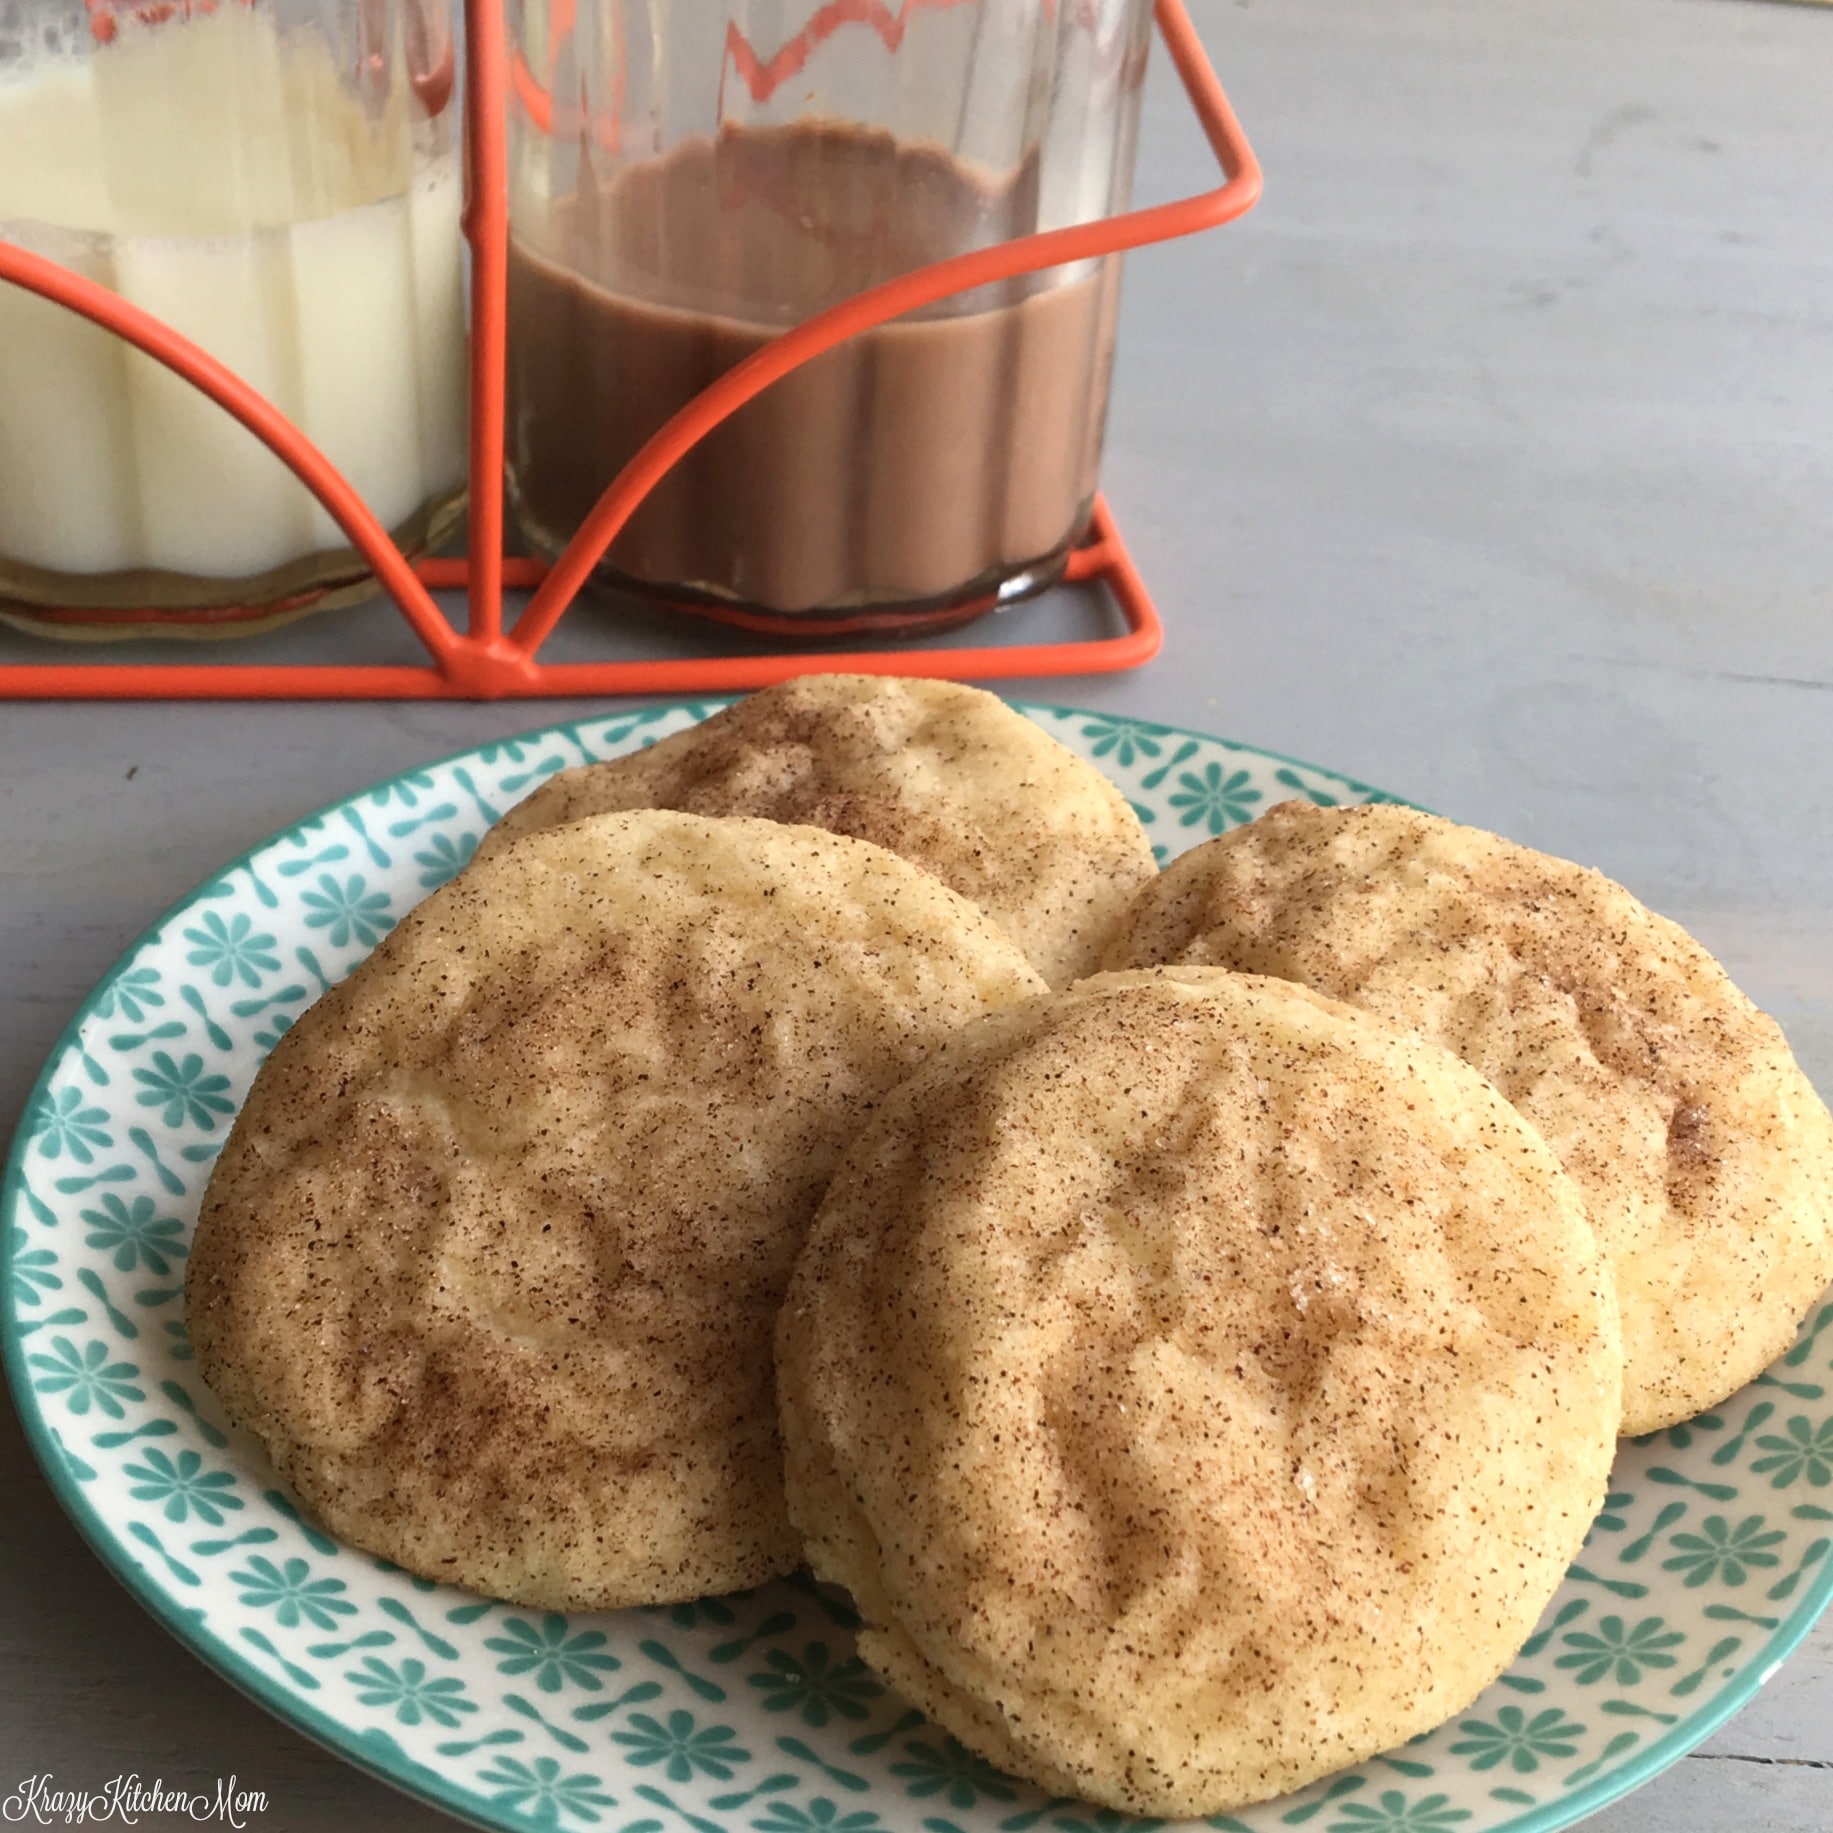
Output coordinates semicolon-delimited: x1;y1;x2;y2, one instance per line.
185;812;1043;1609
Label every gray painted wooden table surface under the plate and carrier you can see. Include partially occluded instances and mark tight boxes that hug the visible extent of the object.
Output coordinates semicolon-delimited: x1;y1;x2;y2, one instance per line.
0;0;1833;1833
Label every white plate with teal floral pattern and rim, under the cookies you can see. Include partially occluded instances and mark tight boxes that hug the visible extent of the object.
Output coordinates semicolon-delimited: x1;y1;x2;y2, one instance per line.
0;702;1833;1833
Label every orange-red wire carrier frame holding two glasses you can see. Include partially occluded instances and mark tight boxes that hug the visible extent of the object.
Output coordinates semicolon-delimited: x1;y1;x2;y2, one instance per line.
0;0;1261;700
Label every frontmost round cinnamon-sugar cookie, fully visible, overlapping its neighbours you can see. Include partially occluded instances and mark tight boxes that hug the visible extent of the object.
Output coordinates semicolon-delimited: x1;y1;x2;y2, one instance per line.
777;968;1622;1817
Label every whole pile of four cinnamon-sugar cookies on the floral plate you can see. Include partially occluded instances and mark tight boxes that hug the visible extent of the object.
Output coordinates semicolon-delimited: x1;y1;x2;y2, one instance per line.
187;676;1833;1815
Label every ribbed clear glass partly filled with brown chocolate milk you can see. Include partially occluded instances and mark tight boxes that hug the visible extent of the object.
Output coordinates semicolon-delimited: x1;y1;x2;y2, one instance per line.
508;0;1151;636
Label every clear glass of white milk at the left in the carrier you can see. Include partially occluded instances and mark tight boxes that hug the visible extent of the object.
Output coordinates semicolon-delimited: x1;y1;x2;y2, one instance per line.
0;0;466;636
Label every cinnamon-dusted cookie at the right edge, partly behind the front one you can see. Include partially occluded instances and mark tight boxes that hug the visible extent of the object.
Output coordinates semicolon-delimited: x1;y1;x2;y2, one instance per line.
1107;803;1833;1433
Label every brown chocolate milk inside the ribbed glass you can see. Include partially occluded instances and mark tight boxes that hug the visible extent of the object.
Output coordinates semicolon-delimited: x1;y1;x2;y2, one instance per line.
508;121;1120;618
